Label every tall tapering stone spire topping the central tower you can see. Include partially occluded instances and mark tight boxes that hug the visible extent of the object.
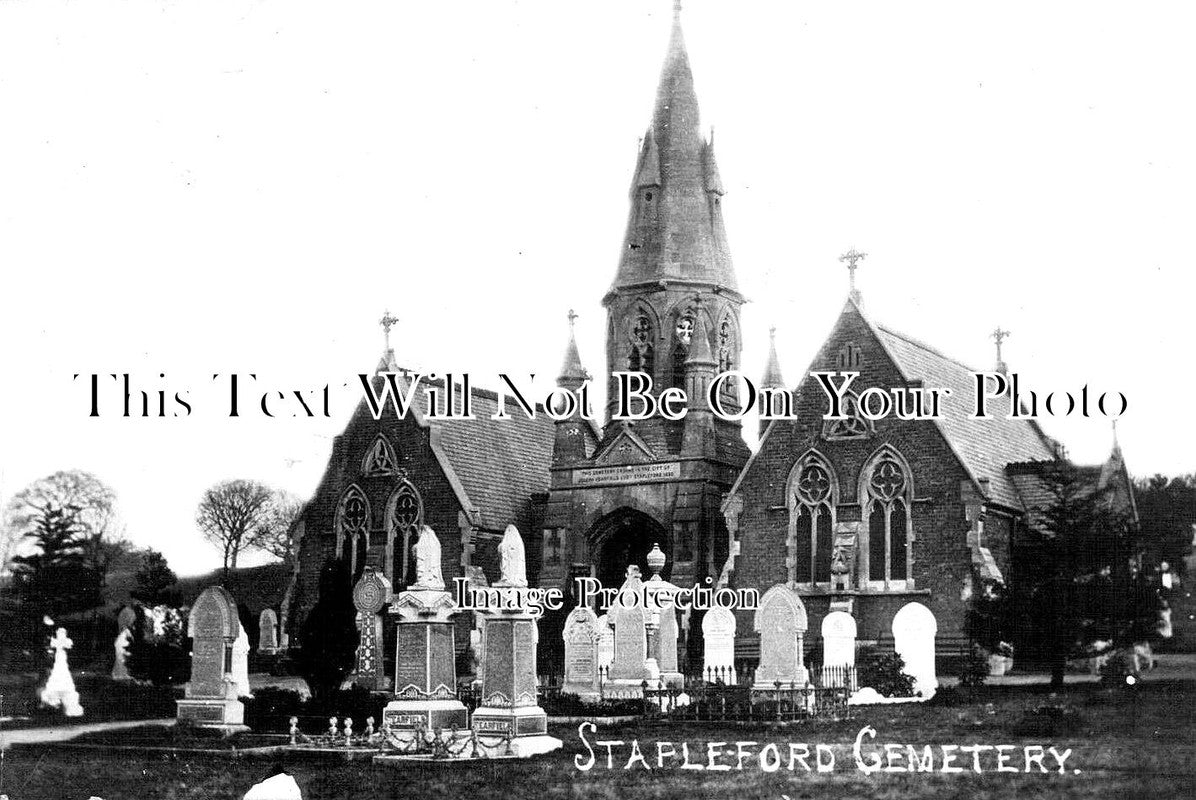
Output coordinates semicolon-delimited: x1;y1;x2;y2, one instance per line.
611;2;738;297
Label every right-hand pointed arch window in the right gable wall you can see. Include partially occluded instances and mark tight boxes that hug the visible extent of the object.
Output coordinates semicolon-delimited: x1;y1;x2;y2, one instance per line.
860;447;914;588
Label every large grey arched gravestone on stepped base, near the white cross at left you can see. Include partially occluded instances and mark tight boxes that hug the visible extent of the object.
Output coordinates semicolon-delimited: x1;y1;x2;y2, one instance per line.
177;586;248;731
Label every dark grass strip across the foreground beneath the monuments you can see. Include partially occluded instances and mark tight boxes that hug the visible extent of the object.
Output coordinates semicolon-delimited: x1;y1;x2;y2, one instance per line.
0;682;1196;800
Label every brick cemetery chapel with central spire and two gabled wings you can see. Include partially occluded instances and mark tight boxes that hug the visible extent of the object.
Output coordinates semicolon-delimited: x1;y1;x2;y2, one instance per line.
283;10;1128;672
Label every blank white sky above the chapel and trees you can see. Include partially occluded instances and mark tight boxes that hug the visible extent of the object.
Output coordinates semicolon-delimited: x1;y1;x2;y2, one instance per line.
0;0;1196;574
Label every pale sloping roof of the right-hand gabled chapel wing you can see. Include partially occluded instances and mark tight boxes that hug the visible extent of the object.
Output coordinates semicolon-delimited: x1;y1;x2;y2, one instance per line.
865;317;1055;508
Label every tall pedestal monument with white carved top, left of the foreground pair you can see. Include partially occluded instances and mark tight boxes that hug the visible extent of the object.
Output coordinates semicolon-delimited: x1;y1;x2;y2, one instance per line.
378;525;469;746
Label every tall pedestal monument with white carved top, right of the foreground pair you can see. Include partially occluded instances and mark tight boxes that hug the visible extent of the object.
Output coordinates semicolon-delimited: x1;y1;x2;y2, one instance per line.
472;525;562;758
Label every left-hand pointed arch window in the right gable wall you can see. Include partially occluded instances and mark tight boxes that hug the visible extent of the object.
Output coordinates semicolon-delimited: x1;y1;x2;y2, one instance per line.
788;452;838;586
